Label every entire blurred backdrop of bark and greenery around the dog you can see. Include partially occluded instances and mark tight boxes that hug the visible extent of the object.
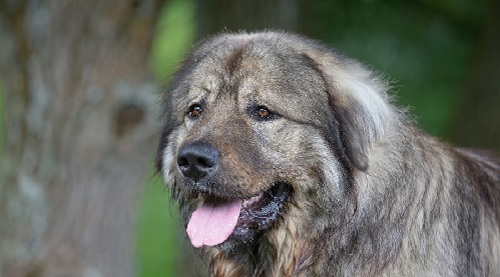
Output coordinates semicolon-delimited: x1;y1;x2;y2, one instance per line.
0;0;500;277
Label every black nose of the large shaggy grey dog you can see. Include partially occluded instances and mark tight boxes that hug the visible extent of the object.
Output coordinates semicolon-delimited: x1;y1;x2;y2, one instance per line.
177;142;220;181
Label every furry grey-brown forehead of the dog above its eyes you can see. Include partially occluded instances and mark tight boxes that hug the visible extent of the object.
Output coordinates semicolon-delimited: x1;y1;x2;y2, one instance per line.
192;40;323;97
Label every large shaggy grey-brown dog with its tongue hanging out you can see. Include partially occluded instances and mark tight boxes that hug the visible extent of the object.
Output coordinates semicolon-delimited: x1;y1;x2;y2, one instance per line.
157;32;500;276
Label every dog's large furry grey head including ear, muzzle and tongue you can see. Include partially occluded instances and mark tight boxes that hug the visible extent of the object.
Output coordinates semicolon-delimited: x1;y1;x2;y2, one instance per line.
157;32;392;249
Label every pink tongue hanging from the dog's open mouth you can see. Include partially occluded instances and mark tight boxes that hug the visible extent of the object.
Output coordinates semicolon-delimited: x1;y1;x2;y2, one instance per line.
186;199;241;247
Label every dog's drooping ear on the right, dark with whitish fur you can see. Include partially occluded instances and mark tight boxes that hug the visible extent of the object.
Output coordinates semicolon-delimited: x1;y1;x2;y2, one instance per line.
302;51;394;171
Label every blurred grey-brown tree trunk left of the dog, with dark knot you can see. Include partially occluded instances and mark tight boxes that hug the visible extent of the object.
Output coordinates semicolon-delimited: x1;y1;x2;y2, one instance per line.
0;0;160;277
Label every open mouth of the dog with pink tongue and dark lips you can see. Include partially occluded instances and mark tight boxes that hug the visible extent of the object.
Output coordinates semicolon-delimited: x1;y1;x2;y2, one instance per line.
186;183;291;247
